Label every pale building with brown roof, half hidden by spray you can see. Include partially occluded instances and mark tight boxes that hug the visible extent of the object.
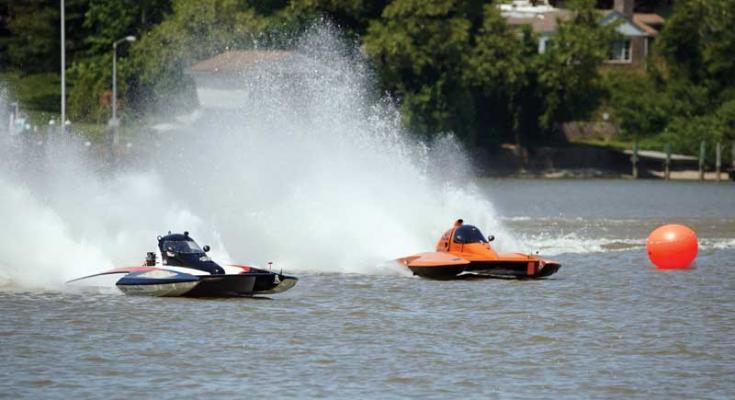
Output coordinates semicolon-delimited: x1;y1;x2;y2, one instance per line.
187;50;293;109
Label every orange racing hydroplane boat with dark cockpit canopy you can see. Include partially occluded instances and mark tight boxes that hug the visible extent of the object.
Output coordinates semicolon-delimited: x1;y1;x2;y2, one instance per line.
398;219;561;279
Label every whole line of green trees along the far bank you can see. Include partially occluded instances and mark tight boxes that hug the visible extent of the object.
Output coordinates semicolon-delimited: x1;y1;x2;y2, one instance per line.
0;0;735;152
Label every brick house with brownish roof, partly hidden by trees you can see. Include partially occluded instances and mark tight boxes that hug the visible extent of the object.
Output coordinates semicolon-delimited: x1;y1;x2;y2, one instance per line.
499;0;664;68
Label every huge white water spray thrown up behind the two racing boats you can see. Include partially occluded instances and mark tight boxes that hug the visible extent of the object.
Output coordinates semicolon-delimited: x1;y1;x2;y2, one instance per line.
0;27;507;286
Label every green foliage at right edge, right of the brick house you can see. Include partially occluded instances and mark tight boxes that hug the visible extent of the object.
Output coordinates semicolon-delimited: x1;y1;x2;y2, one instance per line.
606;0;735;159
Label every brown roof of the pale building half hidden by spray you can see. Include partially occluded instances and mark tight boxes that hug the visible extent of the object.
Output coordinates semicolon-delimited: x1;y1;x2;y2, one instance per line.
189;50;292;73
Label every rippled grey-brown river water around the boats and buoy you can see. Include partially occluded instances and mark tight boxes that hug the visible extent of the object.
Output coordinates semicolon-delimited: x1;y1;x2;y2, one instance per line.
0;180;735;399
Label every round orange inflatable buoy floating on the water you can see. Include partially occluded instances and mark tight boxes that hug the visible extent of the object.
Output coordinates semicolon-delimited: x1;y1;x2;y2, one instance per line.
646;224;699;269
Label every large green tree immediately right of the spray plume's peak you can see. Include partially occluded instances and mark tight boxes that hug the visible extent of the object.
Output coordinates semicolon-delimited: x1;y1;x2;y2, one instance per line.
364;0;475;142
